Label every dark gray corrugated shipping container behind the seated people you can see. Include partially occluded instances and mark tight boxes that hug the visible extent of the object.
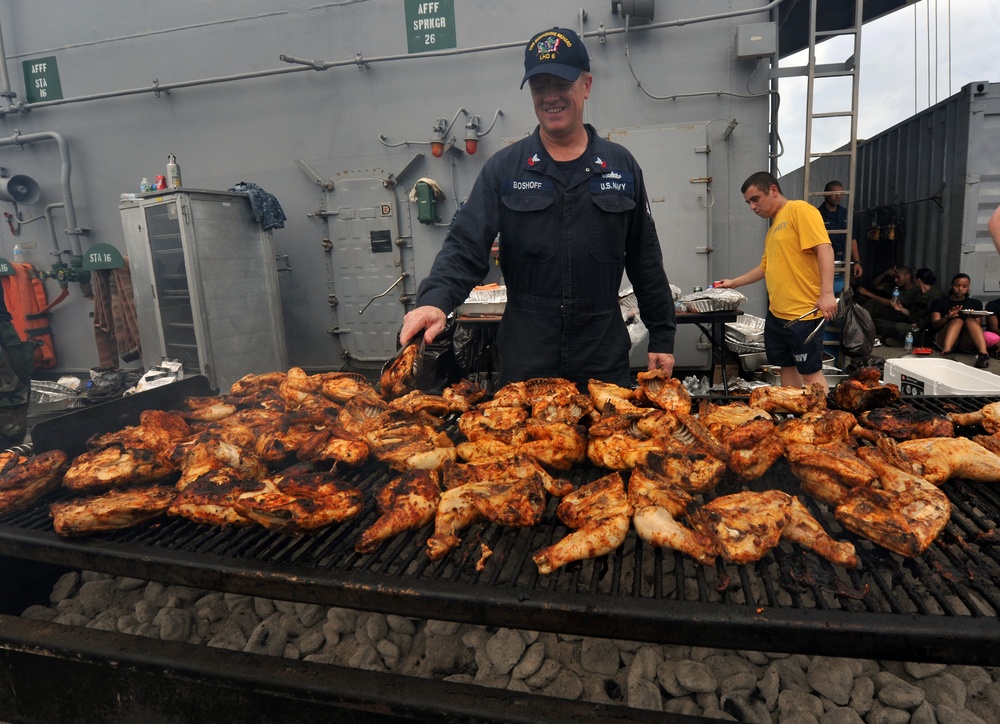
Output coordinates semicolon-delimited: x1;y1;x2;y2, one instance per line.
782;81;1000;300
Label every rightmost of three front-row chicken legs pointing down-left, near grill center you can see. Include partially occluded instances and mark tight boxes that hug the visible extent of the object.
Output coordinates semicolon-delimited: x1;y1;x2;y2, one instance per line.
532;473;632;575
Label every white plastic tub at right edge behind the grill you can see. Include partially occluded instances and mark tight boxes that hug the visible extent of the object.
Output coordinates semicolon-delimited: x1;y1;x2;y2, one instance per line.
882;357;1000;397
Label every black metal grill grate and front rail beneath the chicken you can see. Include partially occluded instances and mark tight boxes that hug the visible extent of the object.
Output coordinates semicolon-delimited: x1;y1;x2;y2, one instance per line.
0;388;1000;665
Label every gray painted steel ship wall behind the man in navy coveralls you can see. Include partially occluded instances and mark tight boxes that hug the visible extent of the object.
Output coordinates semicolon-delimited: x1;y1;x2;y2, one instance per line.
0;0;769;371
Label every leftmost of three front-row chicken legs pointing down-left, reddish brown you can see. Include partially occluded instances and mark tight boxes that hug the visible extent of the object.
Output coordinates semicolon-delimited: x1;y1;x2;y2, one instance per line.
354;470;441;553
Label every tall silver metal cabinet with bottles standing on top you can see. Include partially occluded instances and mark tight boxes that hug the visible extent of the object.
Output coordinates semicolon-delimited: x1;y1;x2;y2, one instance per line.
119;189;288;390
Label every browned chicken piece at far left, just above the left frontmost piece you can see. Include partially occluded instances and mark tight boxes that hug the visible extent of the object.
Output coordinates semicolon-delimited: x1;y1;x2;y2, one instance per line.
63;445;177;491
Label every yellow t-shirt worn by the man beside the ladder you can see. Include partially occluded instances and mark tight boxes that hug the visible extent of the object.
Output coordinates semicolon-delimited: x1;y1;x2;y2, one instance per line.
760;201;830;319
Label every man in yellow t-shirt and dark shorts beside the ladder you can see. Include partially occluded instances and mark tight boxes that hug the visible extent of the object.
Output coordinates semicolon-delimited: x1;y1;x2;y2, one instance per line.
716;171;837;388
